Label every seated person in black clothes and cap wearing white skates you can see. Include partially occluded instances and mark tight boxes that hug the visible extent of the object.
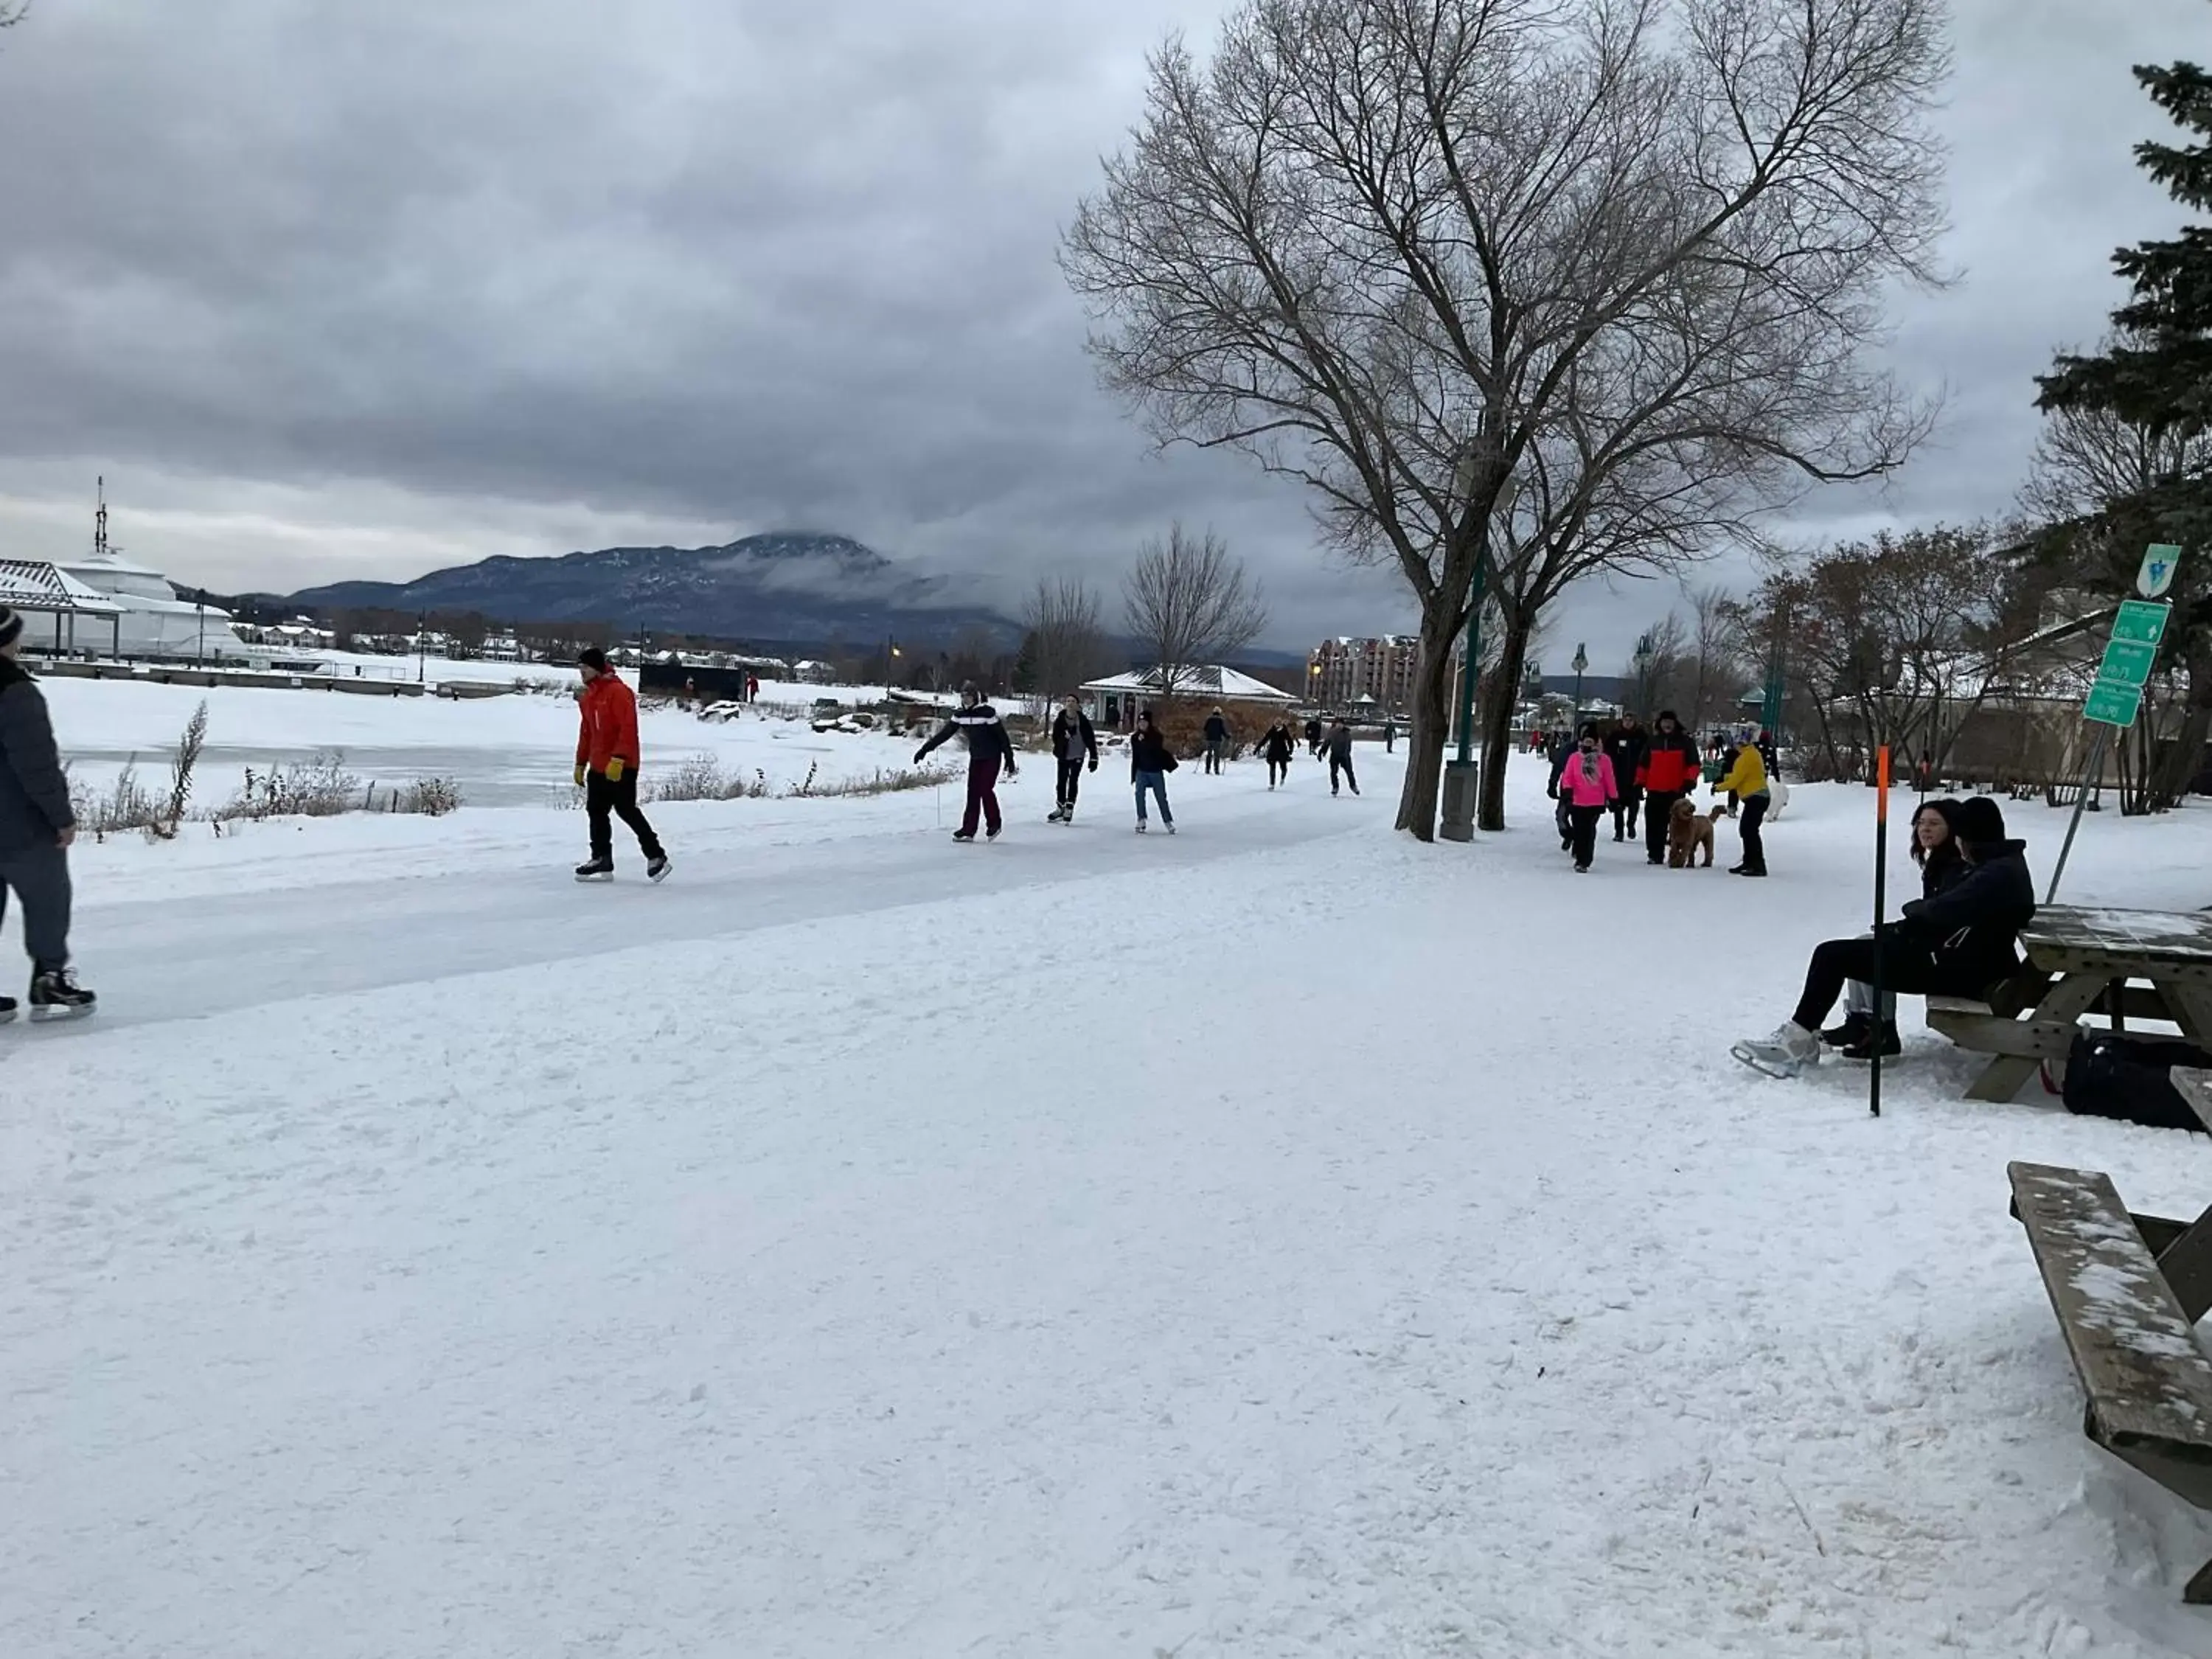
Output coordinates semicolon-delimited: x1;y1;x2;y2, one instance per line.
1730;794;2035;1077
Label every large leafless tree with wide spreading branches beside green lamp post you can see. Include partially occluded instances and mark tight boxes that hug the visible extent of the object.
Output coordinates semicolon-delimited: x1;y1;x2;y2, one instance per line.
1062;0;1947;838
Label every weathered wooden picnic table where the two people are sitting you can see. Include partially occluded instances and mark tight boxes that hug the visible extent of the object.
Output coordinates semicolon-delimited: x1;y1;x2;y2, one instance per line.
1929;905;2212;1099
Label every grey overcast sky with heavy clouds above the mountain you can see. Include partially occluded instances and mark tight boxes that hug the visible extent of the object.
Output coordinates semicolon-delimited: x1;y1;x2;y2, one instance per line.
0;0;2212;668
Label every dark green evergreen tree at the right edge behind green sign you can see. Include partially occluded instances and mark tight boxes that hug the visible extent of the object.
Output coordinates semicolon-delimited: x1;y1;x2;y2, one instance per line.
2037;45;2212;810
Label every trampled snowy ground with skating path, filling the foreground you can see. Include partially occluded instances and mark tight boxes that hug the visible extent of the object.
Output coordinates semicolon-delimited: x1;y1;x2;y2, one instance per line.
0;757;2212;1659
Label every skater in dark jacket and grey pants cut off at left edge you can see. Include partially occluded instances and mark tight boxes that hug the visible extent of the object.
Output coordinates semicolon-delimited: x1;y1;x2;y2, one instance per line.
0;604;95;1024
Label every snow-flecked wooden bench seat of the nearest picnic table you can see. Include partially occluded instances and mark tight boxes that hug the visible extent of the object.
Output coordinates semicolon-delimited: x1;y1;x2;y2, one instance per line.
2006;1071;2212;1606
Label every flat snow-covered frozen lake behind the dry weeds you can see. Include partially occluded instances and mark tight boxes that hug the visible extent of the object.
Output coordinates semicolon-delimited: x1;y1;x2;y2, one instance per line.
42;664;914;805
